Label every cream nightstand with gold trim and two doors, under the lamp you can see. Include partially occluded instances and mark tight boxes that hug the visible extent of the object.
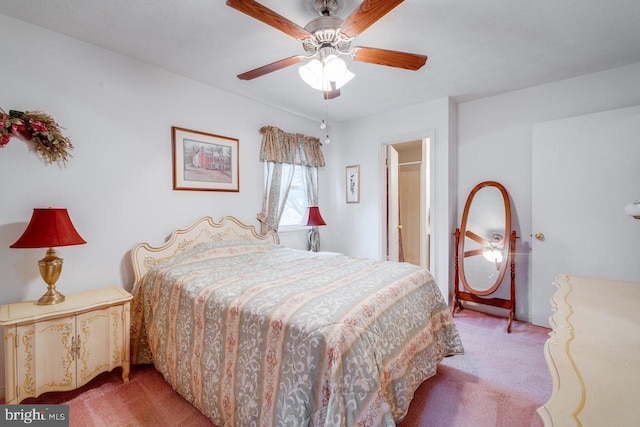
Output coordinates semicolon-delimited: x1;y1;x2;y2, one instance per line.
0;287;133;404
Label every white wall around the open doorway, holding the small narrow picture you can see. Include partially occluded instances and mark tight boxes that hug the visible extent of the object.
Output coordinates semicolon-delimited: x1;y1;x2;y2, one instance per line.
320;98;456;302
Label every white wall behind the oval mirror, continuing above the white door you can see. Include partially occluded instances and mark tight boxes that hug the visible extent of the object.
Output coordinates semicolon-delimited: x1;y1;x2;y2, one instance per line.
457;64;640;320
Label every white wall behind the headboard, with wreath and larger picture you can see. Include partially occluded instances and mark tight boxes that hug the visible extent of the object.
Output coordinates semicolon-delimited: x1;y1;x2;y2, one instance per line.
0;15;322;396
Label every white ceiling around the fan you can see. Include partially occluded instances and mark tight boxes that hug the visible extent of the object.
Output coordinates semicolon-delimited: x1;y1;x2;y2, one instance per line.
0;0;640;121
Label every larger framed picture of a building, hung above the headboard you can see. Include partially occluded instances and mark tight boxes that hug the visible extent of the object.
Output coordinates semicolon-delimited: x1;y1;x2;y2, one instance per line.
171;126;240;191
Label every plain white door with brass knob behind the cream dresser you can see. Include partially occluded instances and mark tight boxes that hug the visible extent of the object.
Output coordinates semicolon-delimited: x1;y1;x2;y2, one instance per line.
530;107;640;327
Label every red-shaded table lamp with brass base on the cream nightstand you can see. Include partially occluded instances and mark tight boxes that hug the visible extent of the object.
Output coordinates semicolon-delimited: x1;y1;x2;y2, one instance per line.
10;208;87;305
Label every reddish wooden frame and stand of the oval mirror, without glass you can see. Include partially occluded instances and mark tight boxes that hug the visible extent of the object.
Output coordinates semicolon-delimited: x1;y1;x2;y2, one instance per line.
451;181;516;333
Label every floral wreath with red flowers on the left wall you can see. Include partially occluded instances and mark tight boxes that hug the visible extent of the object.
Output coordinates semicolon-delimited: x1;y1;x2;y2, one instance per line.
0;108;73;163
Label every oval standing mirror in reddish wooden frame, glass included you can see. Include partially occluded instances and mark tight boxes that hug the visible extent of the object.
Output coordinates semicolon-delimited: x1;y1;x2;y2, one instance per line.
453;181;515;332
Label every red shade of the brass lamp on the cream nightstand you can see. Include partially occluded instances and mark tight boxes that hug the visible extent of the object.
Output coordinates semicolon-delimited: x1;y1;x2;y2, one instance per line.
10;208;87;248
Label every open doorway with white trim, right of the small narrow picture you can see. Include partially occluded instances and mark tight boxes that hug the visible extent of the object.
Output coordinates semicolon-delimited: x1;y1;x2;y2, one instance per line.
384;138;431;269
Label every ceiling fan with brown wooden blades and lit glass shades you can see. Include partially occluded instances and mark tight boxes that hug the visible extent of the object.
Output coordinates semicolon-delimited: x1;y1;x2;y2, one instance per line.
227;0;427;99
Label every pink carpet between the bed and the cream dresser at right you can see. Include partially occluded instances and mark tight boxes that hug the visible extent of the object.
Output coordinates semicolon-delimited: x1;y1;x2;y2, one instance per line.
400;309;551;427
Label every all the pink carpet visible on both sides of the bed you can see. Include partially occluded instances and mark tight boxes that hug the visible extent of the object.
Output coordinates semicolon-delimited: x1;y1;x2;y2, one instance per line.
3;310;551;427
